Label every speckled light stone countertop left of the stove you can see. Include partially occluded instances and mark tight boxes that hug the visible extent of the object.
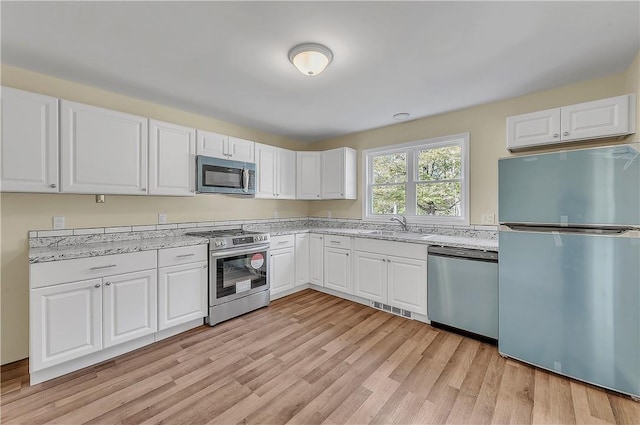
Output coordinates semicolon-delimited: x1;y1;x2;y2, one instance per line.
29;236;209;264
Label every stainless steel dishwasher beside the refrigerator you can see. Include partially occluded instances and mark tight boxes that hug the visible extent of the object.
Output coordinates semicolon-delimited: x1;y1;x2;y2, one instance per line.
427;246;498;342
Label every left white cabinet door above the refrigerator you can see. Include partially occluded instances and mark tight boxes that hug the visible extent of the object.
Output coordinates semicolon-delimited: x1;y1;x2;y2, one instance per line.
507;108;560;149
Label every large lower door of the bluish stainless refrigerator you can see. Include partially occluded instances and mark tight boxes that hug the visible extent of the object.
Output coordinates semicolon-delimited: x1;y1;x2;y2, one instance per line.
498;231;640;397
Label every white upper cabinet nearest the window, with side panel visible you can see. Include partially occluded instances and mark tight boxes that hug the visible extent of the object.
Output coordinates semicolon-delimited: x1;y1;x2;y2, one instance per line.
322;148;357;199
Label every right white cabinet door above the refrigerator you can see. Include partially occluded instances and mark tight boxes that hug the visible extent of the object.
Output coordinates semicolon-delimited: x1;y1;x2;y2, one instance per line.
562;95;635;140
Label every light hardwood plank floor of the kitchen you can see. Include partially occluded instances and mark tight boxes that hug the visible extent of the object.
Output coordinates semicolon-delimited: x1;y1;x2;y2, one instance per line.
1;290;640;424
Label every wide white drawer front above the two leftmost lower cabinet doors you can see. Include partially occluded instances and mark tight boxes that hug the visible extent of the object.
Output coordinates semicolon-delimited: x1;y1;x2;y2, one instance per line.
29;250;157;289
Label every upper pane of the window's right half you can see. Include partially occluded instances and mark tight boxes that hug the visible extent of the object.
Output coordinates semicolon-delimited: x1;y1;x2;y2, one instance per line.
418;146;462;181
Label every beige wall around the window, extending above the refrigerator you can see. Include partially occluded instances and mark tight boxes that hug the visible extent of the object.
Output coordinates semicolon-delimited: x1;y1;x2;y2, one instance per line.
309;55;640;224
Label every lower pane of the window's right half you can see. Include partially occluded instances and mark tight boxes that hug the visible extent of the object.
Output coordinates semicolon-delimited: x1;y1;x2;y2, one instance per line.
416;182;461;217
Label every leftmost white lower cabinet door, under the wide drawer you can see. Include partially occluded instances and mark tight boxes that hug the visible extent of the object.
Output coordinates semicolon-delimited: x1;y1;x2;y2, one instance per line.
29;279;102;372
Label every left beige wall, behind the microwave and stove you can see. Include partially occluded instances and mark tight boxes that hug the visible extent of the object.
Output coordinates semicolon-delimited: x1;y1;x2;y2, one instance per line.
0;65;308;364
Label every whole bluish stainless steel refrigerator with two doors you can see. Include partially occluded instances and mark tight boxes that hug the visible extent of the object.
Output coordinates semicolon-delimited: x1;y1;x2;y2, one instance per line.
498;144;640;398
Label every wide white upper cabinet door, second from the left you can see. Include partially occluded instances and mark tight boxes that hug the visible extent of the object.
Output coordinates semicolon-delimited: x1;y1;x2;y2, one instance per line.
60;100;148;195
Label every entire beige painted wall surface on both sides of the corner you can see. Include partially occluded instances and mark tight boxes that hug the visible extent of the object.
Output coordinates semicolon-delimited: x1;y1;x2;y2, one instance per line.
0;50;640;364
